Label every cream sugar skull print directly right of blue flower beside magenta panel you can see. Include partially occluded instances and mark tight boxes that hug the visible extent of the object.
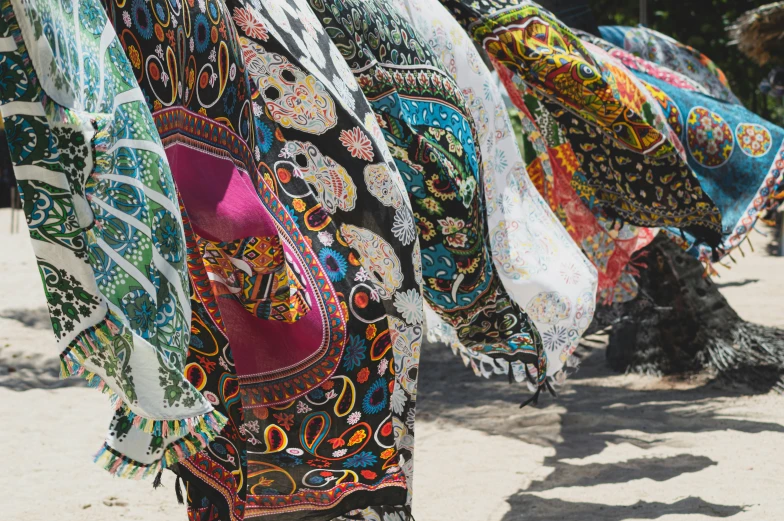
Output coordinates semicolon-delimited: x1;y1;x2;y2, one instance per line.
340;224;403;300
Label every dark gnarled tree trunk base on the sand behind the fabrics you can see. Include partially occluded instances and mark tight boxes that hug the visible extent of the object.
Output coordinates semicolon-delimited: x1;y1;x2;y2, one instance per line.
592;235;784;390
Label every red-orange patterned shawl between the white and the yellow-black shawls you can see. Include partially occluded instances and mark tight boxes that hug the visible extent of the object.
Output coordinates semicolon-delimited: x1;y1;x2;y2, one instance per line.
496;64;655;303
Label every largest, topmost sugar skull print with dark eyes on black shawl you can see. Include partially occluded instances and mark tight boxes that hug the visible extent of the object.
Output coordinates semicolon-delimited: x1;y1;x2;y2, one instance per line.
240;38;337;134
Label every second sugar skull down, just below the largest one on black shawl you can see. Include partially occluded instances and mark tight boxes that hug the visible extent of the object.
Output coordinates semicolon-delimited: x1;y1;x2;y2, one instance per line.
281;141;357;213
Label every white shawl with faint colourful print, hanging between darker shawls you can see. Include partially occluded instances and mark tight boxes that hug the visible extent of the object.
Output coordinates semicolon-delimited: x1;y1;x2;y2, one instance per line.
401;0;597;380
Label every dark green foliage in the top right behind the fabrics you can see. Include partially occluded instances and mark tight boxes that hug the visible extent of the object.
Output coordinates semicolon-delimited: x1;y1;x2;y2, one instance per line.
591;0;784;126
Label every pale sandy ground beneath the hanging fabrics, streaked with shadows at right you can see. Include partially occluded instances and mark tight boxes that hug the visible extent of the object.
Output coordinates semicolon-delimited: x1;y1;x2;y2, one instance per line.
0;205;784;521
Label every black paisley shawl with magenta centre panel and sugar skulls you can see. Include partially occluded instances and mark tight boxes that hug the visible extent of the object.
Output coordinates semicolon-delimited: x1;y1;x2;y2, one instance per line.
100;0;423;521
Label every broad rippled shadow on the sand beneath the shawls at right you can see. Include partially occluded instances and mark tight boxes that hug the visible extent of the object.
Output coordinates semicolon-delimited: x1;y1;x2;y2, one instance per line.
417;336;784;521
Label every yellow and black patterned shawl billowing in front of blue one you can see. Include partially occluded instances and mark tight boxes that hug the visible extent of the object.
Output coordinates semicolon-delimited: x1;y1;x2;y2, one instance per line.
434;0;721;245
